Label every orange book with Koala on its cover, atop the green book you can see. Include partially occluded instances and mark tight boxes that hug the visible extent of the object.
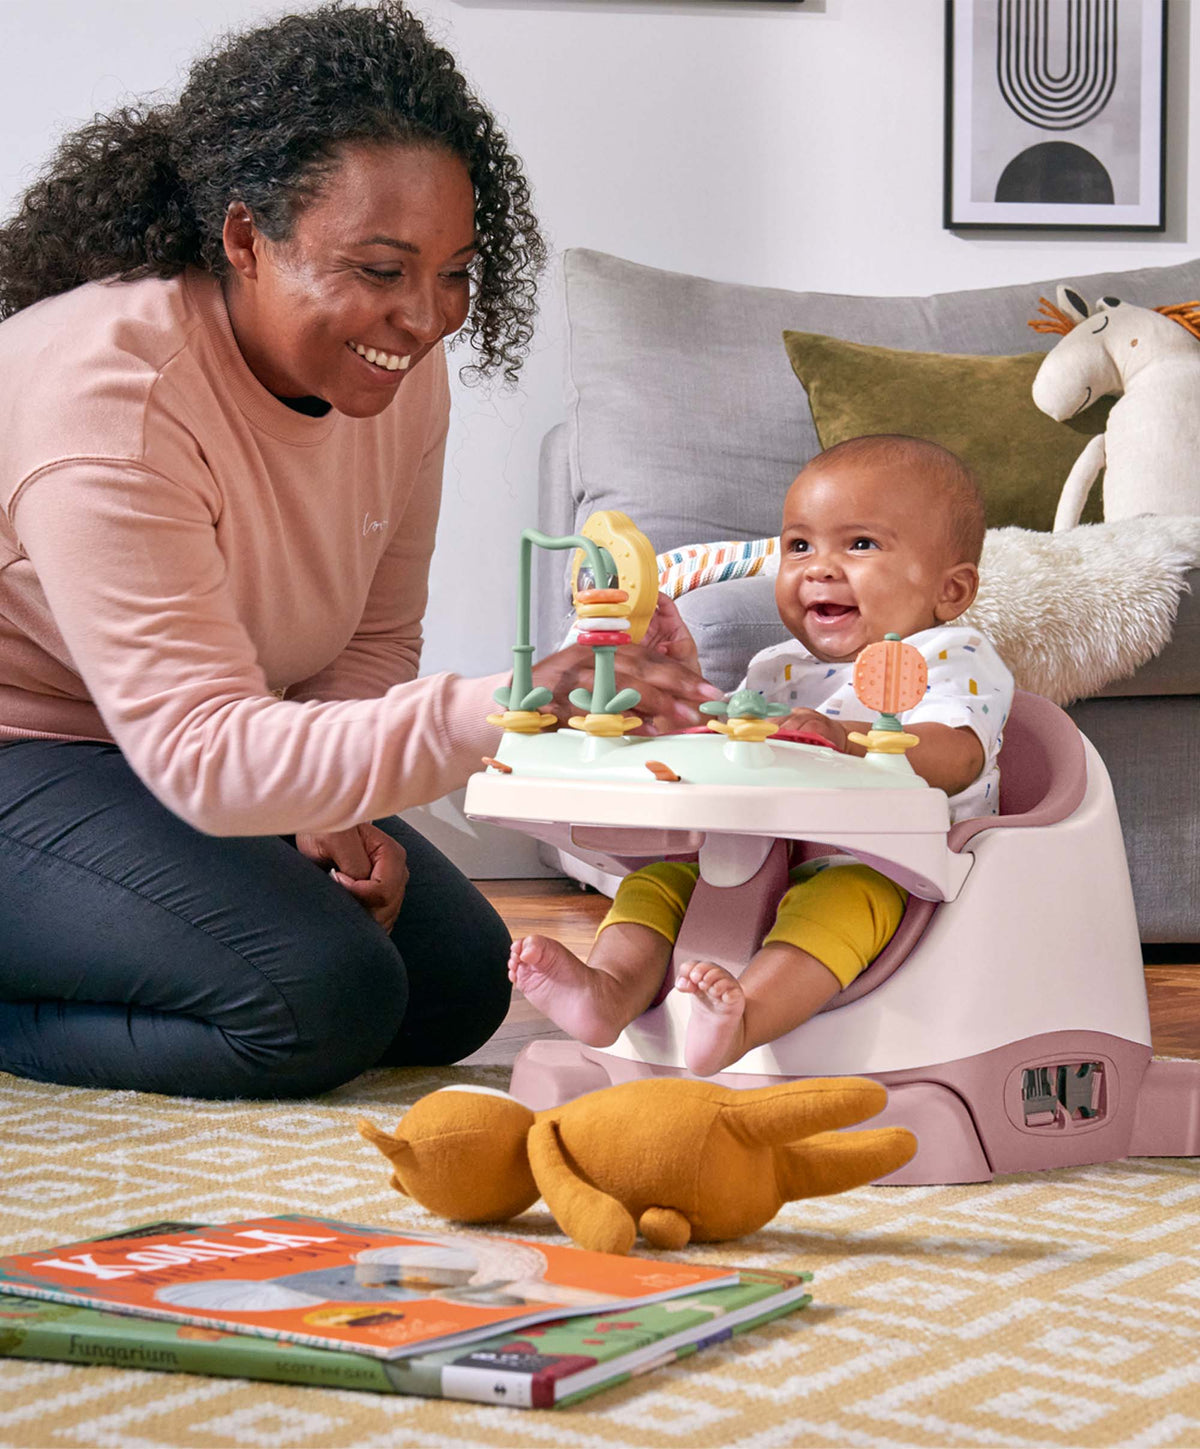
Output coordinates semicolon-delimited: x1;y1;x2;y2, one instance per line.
0;1213;738;1359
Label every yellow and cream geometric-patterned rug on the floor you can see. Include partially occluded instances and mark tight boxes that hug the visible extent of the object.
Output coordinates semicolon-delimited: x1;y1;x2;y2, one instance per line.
0;1068;1200;1449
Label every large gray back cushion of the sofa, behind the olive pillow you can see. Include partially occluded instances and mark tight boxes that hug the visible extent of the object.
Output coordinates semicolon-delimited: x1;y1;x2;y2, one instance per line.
564;248;1200;552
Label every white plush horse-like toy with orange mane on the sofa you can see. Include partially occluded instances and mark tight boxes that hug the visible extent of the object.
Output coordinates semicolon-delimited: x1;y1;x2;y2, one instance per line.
1029;287;1200;532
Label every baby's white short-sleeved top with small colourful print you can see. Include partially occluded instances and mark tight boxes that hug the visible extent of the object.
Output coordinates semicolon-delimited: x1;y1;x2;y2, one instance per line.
739;625;1013;820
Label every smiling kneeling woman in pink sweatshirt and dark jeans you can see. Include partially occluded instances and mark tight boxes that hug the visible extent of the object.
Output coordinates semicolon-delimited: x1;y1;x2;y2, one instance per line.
0;0;712;1097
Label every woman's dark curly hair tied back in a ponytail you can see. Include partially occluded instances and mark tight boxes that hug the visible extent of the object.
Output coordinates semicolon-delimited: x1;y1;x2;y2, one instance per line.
0;0;546;383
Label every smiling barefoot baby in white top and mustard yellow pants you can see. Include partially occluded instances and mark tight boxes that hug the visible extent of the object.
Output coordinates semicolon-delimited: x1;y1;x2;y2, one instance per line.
509;435;1013;1077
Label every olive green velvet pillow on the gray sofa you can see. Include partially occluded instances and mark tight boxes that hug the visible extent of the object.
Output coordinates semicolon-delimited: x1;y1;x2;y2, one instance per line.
784;332;1112;529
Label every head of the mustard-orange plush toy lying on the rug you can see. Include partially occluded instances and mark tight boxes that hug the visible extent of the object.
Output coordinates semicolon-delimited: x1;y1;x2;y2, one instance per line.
358;1088;538;1223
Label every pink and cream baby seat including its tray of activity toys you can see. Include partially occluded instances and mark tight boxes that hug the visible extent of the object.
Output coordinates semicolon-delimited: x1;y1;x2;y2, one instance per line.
465;513;1200;1184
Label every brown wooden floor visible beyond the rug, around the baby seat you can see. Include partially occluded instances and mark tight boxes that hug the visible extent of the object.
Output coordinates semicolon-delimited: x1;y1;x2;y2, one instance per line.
468;880;1200;1066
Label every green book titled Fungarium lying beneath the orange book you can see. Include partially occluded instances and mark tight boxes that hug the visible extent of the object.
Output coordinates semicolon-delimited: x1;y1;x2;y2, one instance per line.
0;1223;812;1408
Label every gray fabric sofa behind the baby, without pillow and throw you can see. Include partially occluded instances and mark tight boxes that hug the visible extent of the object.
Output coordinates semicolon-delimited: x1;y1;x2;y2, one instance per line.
536;249;1200;942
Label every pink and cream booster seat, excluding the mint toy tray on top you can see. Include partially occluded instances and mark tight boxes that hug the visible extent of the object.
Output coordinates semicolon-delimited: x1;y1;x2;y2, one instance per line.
467;691;1200;1184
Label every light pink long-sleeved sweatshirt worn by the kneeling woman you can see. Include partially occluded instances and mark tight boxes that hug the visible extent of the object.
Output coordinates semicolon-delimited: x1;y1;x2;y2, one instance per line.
0;271;504;835
